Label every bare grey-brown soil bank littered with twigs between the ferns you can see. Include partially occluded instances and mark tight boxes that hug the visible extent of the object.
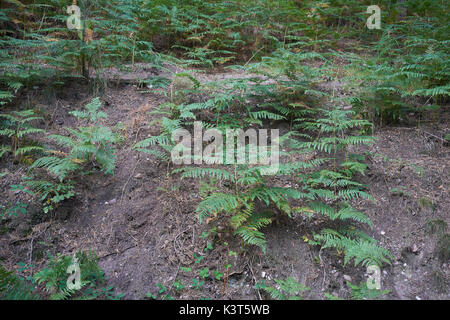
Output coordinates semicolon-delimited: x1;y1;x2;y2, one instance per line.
0;63;450;299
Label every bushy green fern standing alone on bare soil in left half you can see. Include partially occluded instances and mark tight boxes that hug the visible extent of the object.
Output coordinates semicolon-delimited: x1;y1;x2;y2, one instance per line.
17;98;119;213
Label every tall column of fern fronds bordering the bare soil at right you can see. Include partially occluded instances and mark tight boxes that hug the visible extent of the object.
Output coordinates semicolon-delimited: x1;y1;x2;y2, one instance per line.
298;108;393;266
